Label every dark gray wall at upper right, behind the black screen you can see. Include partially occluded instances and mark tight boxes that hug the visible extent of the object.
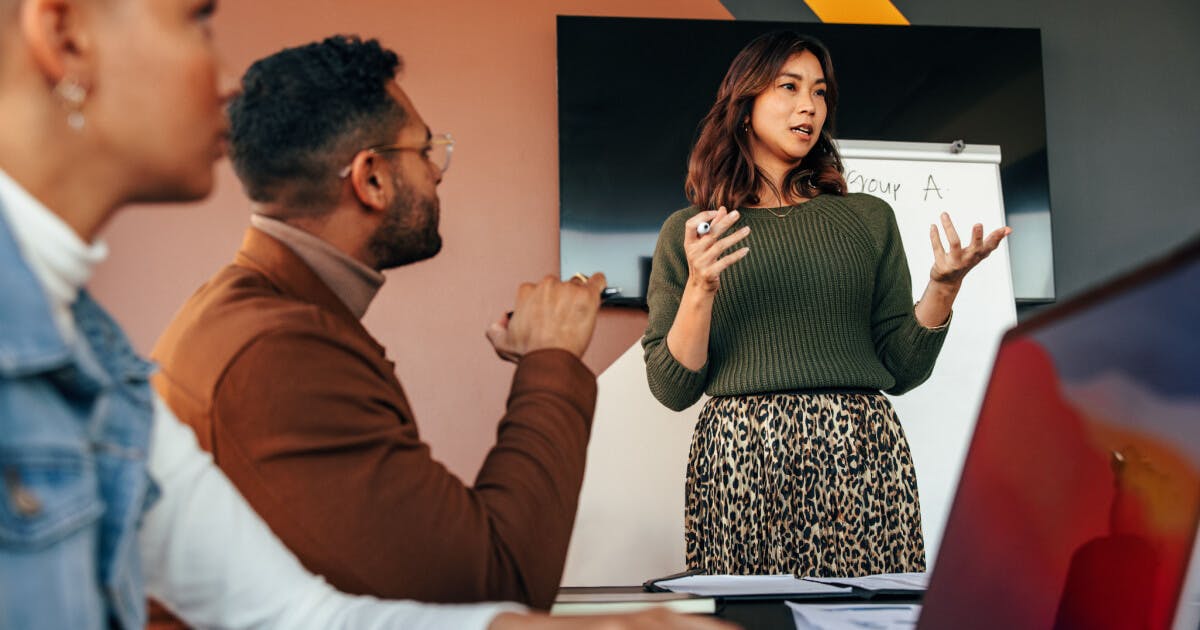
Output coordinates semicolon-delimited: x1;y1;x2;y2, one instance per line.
722;0;1200;304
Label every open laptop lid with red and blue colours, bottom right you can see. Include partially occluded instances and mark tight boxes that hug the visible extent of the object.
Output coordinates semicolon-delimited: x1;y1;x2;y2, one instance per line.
919;239;1200;629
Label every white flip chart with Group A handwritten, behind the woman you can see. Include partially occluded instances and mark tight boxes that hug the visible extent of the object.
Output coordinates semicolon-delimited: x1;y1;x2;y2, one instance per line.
839;140;1016;568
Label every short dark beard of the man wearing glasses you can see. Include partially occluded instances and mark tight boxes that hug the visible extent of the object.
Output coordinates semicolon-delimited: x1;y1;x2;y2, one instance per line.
367;178;442;271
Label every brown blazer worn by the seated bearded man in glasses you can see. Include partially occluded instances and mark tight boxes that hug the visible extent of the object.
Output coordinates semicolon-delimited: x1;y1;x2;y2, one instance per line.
154;228;596;608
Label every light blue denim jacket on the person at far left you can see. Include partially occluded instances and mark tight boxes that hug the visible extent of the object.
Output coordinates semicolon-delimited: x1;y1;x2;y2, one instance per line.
0;207;158;630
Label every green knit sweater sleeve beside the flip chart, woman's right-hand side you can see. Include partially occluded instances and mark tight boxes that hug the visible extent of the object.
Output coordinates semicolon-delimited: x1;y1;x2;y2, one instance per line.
866;198;949;395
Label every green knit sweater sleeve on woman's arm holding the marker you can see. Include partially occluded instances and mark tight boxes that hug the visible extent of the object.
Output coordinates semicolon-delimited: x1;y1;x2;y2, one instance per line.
642;209;708;412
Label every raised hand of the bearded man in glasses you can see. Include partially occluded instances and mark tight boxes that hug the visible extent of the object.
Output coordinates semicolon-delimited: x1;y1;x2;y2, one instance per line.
487;274;607;362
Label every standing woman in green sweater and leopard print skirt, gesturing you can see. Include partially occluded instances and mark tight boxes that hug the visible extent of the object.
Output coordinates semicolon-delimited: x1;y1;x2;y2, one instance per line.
642;32;1009;576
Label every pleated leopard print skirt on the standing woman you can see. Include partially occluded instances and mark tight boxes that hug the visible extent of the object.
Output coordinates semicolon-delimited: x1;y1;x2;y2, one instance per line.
684;392;925;577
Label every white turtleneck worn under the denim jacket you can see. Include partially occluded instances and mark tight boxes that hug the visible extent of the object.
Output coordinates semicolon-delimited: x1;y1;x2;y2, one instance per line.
0;169;524;629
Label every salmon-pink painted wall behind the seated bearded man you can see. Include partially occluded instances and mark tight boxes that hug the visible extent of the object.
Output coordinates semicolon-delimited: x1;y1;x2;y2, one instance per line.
91;0;731;479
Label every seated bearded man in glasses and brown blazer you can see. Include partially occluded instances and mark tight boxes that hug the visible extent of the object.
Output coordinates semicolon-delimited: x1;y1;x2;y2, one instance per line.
154;37;604;608
